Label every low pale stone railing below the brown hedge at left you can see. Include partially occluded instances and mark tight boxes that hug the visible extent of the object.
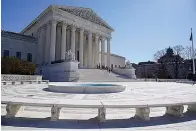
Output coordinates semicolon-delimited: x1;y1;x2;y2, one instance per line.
1;74;42;81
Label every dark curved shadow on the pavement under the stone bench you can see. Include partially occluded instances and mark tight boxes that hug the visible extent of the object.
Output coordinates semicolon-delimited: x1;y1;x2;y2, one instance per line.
1;112;196;129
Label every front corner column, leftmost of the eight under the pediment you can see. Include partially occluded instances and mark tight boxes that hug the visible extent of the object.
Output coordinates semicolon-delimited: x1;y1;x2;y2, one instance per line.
50;20;57;62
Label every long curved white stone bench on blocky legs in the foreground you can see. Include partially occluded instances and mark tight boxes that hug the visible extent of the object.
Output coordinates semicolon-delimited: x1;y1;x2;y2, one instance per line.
1;96;196;122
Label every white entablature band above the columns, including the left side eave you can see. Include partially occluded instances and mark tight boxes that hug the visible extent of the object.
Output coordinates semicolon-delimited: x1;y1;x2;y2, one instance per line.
21;5;113;38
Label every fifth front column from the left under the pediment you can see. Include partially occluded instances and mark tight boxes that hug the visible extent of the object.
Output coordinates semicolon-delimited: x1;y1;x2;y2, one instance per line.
88;31;92;67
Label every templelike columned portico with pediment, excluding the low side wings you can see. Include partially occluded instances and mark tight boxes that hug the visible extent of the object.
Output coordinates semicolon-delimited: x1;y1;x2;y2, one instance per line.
21;6;114;68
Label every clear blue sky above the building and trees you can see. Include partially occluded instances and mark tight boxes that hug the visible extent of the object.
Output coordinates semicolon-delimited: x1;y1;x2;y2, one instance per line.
2;0;196;63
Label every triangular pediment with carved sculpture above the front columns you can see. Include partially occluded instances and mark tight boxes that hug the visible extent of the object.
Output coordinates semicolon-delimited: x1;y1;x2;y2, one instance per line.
57;6;114;31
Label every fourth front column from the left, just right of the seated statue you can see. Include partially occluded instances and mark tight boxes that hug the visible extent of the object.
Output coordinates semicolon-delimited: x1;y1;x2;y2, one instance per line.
79;29;84;67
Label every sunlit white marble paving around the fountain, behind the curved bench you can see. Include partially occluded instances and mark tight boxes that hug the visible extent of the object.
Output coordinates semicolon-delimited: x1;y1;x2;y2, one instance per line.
2;82;196;101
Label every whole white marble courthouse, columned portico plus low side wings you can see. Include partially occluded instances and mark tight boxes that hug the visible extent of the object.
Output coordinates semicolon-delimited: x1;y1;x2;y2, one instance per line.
1;5;125;68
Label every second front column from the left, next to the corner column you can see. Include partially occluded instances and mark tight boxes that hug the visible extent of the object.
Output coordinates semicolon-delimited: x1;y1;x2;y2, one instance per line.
61;22;67;60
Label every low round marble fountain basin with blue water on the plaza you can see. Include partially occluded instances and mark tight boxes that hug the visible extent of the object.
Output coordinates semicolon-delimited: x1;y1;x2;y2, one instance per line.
48;84;126;94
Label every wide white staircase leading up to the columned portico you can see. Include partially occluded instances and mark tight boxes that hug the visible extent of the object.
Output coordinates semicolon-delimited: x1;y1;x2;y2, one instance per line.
78;69;132;82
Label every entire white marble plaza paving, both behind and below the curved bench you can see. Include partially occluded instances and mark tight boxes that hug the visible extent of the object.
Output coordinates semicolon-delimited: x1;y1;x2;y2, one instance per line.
1;82;196;131
